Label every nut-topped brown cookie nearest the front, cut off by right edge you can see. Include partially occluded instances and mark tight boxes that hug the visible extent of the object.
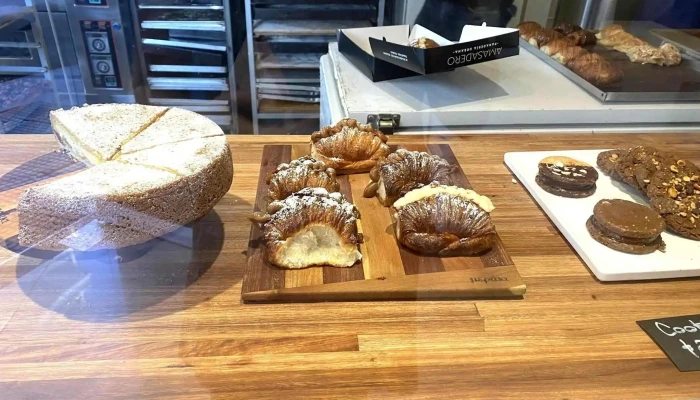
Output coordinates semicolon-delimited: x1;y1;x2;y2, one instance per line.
647;159;700;240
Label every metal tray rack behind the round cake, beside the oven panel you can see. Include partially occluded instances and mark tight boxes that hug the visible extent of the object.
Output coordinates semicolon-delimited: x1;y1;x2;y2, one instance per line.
132;0;238;133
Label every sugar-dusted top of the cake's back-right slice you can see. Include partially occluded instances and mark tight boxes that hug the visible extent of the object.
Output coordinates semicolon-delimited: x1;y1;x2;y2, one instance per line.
121;108;224;154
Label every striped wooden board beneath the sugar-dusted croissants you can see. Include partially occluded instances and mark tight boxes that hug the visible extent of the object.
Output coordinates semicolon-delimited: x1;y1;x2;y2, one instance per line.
242;144;525;302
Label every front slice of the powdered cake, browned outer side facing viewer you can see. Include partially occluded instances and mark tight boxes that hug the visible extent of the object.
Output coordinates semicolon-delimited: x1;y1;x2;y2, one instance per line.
18;161;191;250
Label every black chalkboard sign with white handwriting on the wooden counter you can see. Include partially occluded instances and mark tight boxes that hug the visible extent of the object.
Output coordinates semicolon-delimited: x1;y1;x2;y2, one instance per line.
637;315;700;372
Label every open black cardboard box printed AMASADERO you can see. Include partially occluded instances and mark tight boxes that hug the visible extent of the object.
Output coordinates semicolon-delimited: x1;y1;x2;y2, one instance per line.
338;25;519;82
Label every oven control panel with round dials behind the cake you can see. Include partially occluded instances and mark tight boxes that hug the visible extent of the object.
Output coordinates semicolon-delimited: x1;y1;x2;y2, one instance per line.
76;20;122;89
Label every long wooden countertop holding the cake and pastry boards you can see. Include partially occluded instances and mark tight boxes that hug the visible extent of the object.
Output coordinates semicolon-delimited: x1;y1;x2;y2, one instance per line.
0;134;700;399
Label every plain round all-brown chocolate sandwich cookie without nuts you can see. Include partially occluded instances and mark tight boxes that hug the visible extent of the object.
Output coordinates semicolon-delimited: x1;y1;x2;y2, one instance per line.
586;200;666;254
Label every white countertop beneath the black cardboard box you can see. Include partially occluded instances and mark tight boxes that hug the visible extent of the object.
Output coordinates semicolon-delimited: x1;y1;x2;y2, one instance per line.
321;43;700;132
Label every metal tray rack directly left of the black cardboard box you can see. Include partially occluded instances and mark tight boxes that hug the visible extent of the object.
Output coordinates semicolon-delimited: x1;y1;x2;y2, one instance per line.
245;0;385;135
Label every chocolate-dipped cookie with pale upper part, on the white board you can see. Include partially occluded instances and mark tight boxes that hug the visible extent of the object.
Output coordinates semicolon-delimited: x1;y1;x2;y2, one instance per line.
535;156;598;198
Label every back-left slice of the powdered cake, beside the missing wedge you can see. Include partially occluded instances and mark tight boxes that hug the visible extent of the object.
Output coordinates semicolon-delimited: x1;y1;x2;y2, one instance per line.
50;104;168;165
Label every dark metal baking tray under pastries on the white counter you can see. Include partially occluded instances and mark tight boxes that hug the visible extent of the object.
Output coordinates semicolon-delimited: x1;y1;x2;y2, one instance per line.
520;39;700;103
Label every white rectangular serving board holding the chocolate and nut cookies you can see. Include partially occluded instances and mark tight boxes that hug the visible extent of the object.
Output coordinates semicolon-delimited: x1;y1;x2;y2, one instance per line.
505;149;700;281
